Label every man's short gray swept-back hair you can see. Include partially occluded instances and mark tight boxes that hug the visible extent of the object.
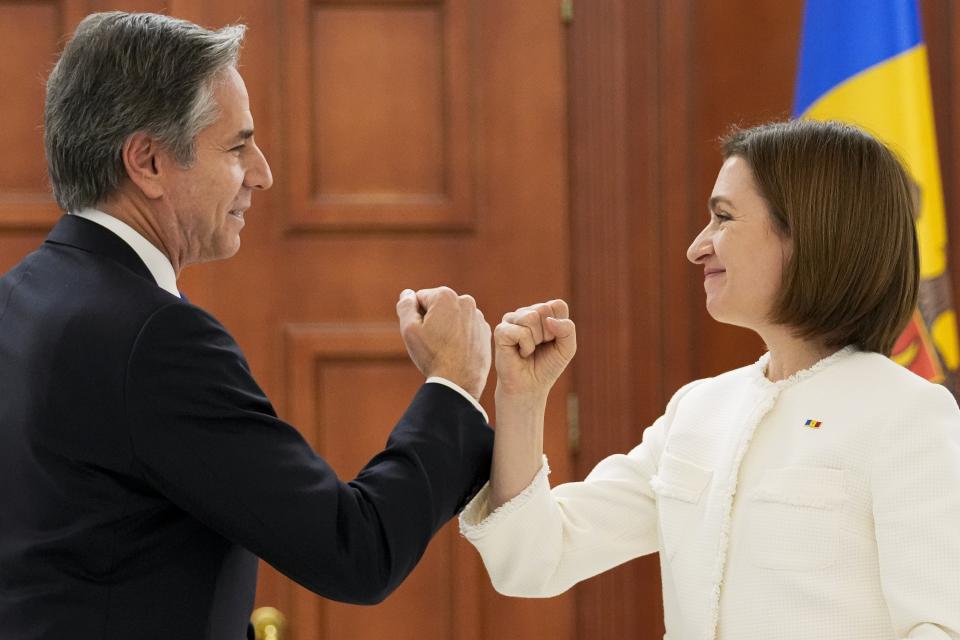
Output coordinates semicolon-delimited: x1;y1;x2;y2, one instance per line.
44;11;246;211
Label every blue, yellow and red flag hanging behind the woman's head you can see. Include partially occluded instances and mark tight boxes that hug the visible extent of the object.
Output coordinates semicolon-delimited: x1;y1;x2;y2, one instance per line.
794;0;960;393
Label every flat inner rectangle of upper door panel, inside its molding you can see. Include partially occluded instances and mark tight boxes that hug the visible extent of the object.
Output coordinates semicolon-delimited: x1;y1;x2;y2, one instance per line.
310;6;445;195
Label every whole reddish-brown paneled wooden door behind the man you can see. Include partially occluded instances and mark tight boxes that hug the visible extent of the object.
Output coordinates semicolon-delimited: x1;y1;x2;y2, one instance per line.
0;0;575;640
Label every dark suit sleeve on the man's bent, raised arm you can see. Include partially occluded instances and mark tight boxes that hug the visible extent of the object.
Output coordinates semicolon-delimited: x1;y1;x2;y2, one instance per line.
125;304;492;604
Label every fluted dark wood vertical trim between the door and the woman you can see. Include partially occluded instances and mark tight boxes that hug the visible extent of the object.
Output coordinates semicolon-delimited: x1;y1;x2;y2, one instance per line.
568;0;639;640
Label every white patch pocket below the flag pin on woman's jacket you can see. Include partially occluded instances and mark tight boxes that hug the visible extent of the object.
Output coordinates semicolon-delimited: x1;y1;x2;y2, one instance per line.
745;467;844;571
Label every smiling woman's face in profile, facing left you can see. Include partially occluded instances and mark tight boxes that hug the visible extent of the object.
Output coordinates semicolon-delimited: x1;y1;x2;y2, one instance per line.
687;156;790;330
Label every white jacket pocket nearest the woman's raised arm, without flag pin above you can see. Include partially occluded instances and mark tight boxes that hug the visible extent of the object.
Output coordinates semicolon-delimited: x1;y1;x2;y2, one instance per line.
650;452;713;560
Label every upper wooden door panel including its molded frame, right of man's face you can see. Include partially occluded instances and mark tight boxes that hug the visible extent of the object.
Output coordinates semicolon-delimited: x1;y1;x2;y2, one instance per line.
282;0;474;231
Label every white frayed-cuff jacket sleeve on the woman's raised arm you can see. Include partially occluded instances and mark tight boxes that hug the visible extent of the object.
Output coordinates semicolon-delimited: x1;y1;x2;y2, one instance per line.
460;383;696;597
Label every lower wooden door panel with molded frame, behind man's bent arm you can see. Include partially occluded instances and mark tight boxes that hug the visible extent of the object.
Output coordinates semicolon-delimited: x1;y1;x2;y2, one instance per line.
287;324;456;640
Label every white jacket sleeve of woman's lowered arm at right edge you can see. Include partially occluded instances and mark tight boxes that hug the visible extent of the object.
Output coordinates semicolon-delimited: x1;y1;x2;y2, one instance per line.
871;385;960;640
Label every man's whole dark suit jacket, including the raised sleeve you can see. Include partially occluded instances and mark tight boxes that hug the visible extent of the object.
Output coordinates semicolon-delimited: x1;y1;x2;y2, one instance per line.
0;216;492;640
